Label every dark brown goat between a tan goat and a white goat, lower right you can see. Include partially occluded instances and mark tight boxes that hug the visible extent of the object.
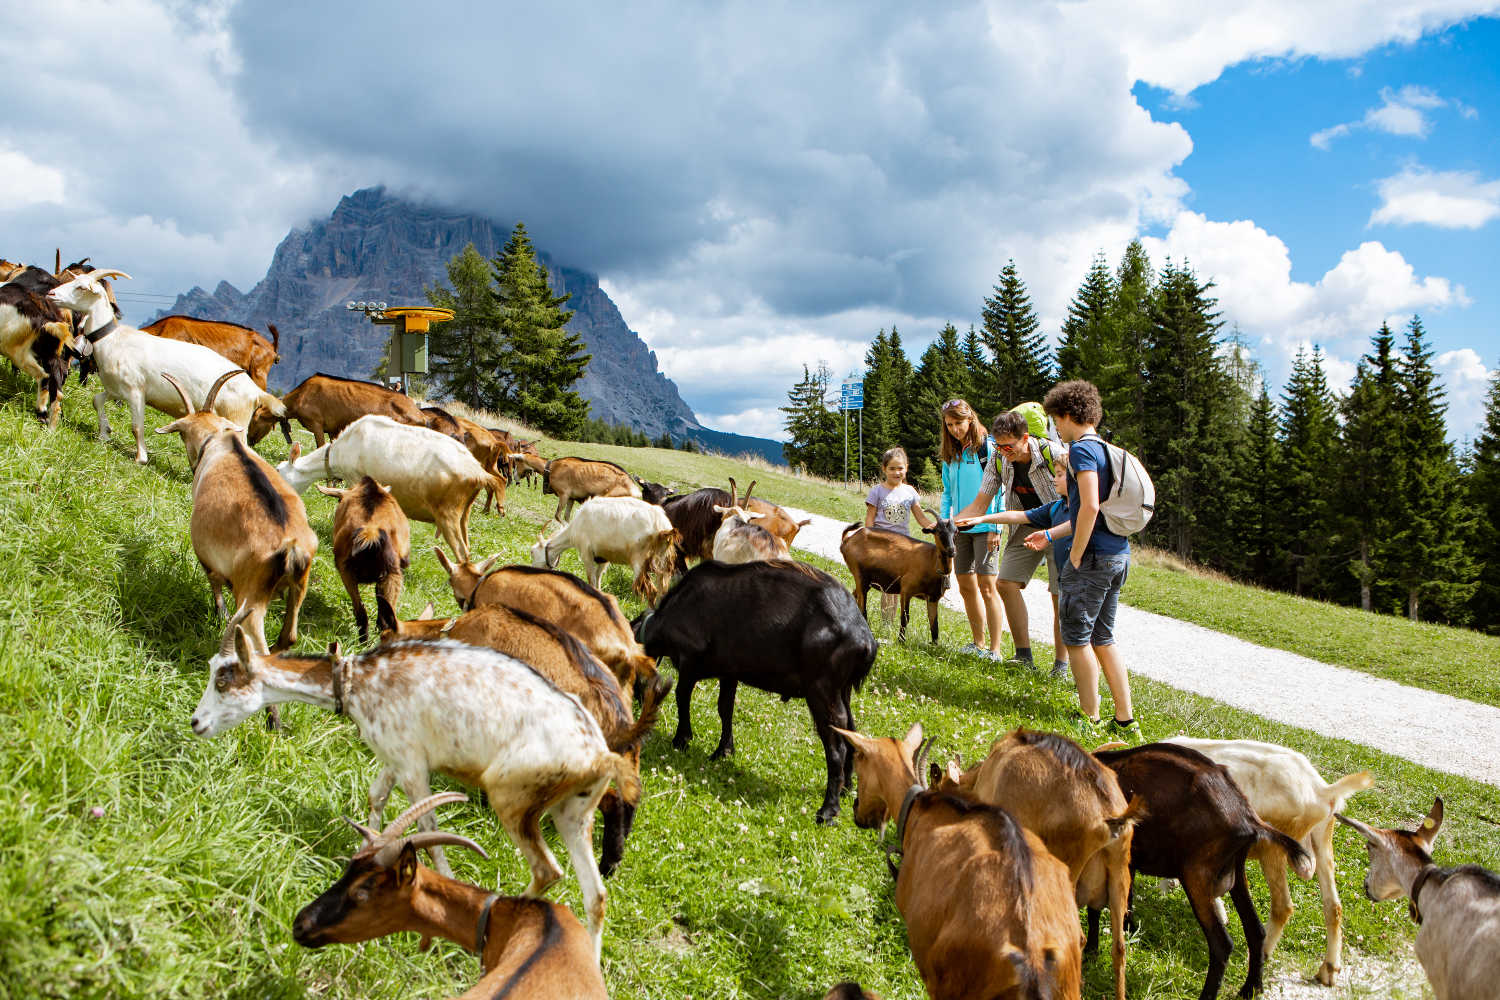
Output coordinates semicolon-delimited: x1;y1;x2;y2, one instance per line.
1089;744;1313;1000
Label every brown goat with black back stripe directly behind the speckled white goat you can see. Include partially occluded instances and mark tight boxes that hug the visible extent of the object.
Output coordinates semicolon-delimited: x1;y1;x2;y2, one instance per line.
381;604;672;879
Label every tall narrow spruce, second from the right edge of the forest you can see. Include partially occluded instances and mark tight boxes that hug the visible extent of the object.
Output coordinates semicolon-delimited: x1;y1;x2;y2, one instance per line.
1395;316;1478;621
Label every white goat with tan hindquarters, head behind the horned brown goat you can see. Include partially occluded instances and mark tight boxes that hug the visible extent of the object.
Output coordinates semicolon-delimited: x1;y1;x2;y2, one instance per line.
276;417;495;561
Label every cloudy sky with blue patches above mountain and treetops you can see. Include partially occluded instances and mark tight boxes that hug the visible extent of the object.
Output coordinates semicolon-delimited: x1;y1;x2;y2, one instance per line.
0;0;1500;438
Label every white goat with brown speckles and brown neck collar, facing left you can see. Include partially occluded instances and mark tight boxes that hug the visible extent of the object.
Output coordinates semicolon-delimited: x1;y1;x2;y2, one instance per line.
192;628;641;961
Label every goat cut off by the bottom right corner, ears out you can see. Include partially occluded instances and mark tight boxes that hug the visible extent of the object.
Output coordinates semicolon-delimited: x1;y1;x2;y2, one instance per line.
1335;798;1500;1000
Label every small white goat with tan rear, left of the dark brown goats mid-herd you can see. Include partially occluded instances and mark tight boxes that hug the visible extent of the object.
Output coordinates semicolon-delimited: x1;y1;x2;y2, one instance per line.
531;496;677;607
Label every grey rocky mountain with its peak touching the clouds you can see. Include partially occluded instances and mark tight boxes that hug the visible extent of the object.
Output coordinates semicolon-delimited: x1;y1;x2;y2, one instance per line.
161;187;783;462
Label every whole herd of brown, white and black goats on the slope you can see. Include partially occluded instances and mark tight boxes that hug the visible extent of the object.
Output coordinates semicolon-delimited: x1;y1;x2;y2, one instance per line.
0;261;1500;1000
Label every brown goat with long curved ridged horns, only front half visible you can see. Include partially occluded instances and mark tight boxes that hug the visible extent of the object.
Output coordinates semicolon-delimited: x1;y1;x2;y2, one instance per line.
293;792;608;1000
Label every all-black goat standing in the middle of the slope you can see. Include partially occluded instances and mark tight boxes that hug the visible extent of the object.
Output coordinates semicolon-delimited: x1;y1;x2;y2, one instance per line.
636;561;876;823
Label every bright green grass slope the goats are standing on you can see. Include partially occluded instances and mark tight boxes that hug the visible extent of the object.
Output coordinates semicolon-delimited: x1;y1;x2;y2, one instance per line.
0;370;1500;1000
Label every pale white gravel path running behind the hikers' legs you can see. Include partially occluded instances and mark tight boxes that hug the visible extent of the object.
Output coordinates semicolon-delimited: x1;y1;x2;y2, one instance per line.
788;508;1500;786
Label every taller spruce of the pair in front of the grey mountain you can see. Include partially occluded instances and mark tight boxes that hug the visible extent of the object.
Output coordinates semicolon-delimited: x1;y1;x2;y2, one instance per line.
494;222;590;438
